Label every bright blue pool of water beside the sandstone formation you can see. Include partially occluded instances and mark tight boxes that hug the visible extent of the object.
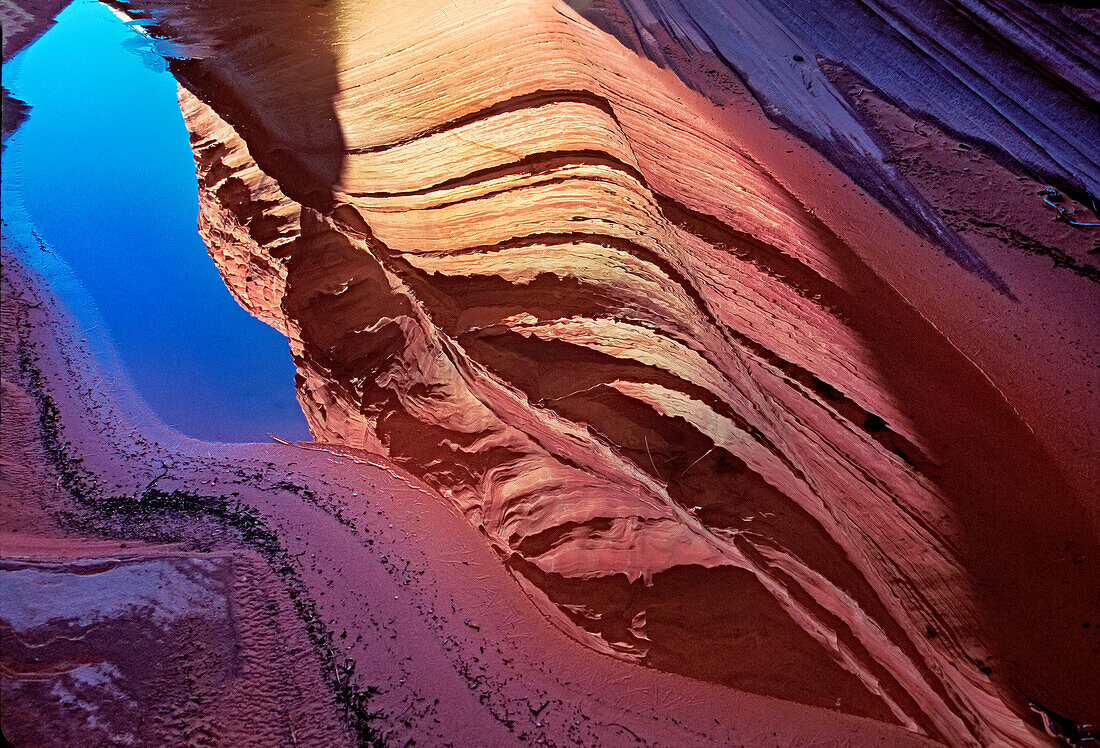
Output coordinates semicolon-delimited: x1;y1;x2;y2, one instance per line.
3;0;308;441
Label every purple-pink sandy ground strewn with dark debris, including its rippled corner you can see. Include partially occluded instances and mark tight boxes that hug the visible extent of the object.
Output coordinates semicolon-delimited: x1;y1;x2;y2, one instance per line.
0;240;946;746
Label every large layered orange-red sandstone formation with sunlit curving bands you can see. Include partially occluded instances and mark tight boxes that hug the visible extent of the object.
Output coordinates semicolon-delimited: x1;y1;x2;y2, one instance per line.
116;0;1097;744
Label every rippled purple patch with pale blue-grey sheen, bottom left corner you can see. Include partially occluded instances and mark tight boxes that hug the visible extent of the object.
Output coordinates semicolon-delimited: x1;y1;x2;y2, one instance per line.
0;550;349;746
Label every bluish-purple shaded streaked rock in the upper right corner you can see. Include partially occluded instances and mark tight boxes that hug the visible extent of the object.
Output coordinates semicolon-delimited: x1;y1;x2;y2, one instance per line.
570;0;1100;283
